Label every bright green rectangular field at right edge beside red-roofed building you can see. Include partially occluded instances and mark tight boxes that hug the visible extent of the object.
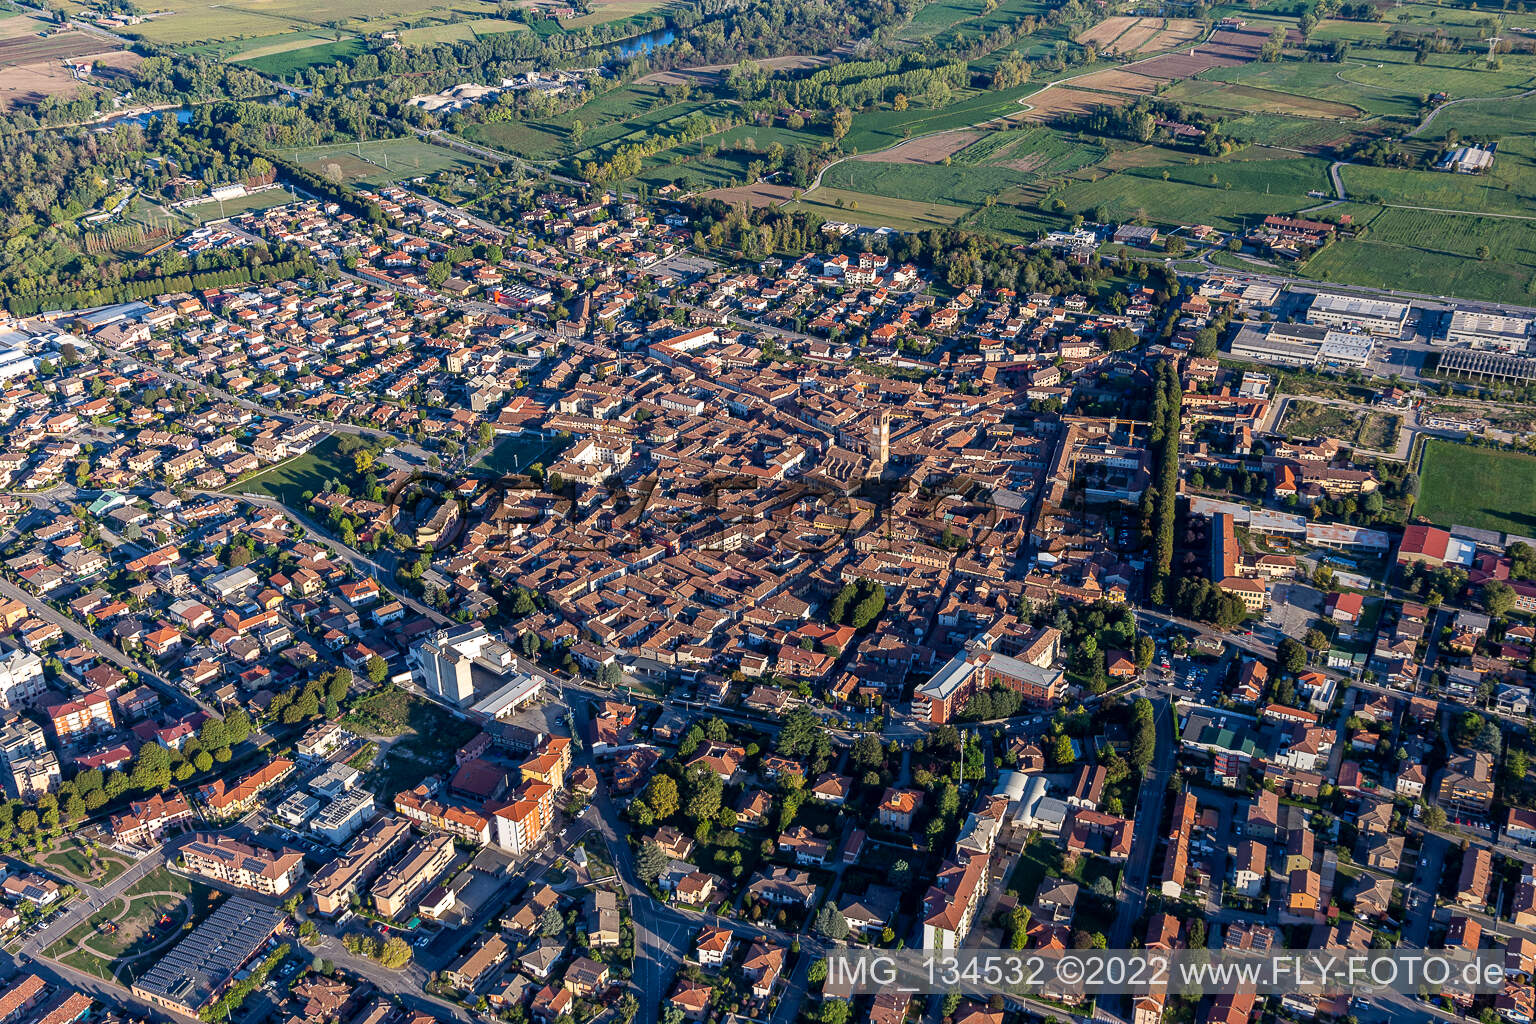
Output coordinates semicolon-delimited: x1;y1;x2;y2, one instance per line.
1413;438;1536;536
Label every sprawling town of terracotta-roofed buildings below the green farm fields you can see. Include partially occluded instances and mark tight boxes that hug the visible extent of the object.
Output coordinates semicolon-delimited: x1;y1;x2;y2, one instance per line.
0;130;1536;1024
